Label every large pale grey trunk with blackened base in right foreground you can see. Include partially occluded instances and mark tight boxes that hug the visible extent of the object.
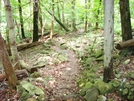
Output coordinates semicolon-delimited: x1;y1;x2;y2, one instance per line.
103;0;114;82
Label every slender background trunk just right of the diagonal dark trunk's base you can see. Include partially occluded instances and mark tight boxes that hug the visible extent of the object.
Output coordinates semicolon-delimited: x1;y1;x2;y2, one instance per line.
72;0;77;31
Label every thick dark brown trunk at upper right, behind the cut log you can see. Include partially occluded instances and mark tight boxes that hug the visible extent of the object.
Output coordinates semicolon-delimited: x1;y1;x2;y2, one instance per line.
119;0;132;41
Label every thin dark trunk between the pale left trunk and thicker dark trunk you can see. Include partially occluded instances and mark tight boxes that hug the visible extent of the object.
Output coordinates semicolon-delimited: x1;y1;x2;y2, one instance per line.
18;0;26;39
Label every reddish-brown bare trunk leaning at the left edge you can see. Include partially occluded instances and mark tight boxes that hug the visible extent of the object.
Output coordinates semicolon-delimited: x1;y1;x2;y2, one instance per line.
0;33;18;90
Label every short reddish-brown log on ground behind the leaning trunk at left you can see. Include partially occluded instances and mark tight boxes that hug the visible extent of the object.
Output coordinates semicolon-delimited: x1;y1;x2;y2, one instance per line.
0;69;28;82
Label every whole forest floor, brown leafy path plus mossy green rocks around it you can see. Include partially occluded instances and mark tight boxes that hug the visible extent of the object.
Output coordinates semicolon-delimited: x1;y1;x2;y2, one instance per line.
0;31;134;101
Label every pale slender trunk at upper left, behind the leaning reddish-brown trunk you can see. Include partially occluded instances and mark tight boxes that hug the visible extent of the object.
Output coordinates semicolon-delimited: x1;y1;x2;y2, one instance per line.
4;0;20;69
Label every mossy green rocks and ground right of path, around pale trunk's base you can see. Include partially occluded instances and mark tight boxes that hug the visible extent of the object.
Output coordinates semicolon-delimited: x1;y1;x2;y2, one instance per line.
77;43;134;101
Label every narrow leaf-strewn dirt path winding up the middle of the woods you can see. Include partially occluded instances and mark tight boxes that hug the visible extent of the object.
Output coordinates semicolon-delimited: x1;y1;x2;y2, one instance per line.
42;38;80;101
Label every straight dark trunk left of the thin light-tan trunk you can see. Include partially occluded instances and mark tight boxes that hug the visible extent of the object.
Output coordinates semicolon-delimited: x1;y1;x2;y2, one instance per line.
33;0;39;42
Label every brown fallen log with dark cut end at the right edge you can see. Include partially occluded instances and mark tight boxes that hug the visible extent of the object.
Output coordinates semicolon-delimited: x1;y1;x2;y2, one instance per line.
115;39;134;50
